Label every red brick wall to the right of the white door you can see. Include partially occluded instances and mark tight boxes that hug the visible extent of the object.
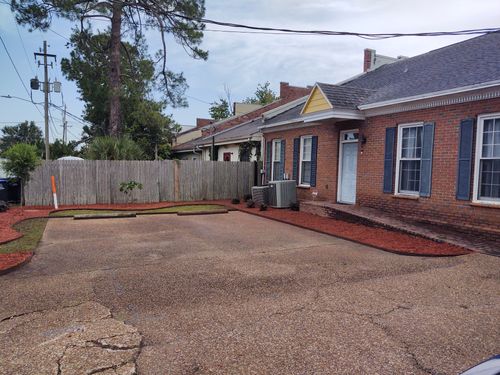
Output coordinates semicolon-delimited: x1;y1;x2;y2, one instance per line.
357;99;500;230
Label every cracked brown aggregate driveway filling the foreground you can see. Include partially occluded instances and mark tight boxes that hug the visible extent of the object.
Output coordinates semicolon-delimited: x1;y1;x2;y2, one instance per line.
0;212;500;375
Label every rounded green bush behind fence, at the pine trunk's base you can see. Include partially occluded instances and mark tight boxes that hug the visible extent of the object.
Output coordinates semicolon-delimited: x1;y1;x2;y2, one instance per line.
85;136;143;160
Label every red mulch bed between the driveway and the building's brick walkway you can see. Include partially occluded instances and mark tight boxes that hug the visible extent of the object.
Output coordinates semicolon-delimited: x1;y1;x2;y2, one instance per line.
231;204;472;256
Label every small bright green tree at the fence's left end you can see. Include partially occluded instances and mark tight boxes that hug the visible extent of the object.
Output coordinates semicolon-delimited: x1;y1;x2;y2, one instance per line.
2;143;40;206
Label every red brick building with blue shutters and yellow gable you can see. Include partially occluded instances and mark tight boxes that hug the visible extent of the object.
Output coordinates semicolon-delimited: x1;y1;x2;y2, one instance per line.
261;33;500;233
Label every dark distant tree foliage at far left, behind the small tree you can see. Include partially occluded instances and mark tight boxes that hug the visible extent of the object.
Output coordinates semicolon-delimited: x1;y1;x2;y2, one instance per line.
0;121;44;155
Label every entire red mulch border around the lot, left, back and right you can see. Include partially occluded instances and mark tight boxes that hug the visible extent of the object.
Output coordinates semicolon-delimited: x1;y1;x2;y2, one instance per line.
0;201;471;273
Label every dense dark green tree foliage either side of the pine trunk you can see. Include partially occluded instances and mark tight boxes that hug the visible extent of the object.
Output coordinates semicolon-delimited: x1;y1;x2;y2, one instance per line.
61;33;179;159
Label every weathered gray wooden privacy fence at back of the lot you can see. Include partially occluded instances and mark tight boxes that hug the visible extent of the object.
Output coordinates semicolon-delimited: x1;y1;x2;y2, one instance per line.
26;160;255;206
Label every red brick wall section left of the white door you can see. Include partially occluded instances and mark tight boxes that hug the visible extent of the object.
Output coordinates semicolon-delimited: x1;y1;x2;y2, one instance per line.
263;121;362;202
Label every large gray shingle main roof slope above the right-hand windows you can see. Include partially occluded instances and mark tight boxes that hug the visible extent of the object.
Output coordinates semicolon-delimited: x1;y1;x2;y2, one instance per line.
343;32;500;104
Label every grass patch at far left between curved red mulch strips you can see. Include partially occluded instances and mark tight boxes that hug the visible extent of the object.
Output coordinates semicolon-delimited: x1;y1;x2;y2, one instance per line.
0;218;47;254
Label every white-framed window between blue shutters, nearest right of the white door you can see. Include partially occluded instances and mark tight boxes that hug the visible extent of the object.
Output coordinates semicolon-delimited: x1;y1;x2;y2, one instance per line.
396;124;423;195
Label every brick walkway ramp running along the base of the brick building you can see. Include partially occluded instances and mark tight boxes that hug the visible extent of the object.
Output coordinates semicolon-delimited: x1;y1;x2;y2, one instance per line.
302;201;500;256
